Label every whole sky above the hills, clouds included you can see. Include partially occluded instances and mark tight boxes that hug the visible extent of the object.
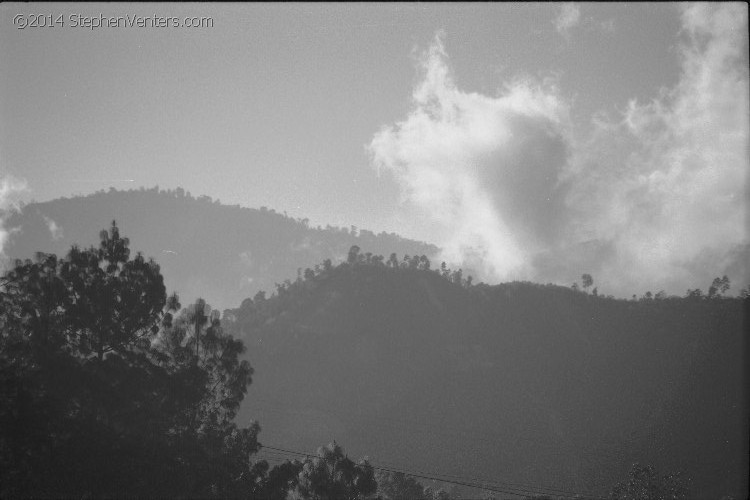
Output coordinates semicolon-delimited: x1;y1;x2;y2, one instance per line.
0;3;750;296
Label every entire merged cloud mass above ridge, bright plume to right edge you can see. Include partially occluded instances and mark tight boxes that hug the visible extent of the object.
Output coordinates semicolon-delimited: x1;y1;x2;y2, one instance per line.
369;4;750;295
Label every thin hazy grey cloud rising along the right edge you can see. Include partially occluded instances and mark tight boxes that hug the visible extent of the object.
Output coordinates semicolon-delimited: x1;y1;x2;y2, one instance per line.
568;0;750;293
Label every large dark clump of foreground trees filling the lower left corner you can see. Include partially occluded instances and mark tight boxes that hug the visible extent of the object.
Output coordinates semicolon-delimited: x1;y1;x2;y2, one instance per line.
0;223;258;498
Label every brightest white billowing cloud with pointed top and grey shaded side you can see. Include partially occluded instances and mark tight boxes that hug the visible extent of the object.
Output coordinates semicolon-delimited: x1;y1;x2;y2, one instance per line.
369;37;568;278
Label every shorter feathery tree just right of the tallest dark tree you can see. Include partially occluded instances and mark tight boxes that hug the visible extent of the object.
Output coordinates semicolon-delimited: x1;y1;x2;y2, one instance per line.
152;299;260;497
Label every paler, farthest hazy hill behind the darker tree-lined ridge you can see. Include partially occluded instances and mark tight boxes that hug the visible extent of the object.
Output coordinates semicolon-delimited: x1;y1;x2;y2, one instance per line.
4;188;437;308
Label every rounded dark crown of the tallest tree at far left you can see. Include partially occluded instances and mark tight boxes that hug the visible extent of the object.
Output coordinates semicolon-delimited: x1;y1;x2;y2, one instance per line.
3;222;174;360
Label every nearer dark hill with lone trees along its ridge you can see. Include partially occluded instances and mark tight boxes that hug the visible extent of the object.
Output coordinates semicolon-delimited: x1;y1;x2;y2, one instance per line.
224;255;750;499
